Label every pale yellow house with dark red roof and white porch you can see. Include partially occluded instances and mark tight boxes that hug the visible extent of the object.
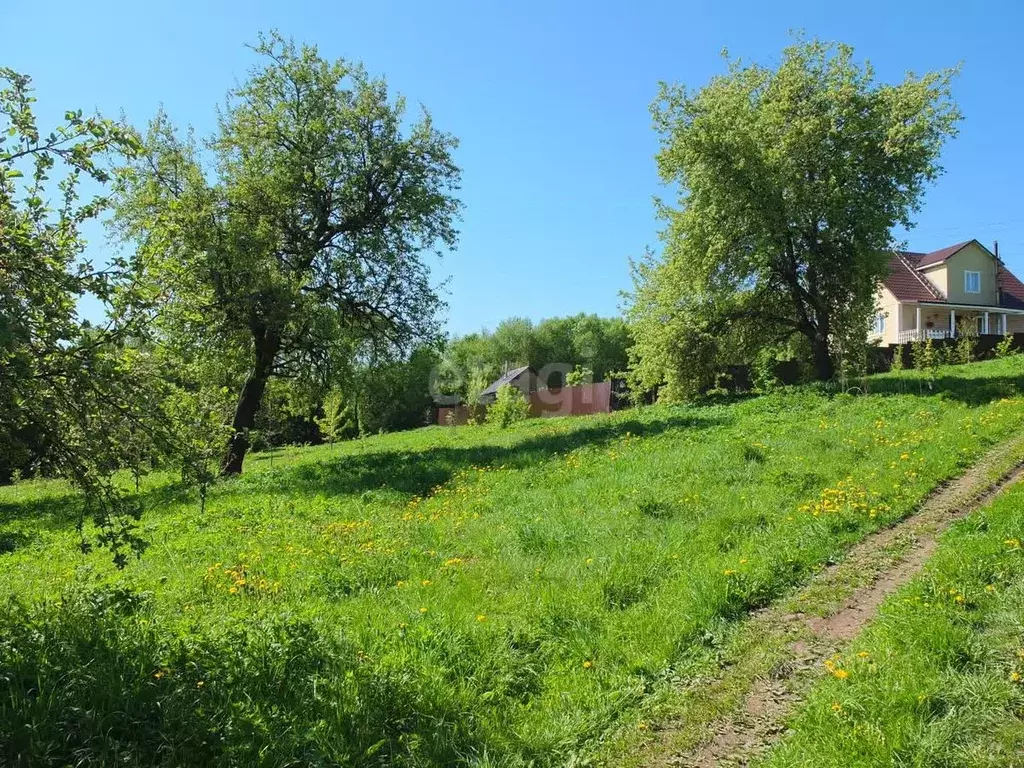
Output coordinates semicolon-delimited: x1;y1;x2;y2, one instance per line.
870;240;1024;346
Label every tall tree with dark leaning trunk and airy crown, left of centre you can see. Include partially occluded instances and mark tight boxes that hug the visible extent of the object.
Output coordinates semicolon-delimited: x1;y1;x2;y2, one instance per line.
118;34;460;474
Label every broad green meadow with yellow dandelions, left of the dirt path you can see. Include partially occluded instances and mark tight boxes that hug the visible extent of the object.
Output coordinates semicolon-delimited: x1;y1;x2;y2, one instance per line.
6;358;1024;766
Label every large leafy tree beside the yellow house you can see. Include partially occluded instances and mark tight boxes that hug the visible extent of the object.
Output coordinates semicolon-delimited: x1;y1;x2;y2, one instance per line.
629;39;961;389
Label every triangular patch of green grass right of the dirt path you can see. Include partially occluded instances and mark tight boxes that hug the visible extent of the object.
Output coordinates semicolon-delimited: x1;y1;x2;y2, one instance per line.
764;473;1024;768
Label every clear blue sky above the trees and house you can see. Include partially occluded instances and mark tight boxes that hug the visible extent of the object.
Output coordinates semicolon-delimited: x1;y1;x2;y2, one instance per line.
8;0;1024;333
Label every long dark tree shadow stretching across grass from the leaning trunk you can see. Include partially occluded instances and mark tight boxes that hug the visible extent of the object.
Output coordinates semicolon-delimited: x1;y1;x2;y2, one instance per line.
224;413;731;496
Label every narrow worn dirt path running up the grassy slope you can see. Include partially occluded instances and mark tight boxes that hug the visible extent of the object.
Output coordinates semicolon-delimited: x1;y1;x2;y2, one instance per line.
645;436;1024;768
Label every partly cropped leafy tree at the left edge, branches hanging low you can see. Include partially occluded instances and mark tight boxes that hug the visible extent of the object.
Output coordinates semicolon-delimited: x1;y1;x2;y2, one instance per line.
0;69;208;565
